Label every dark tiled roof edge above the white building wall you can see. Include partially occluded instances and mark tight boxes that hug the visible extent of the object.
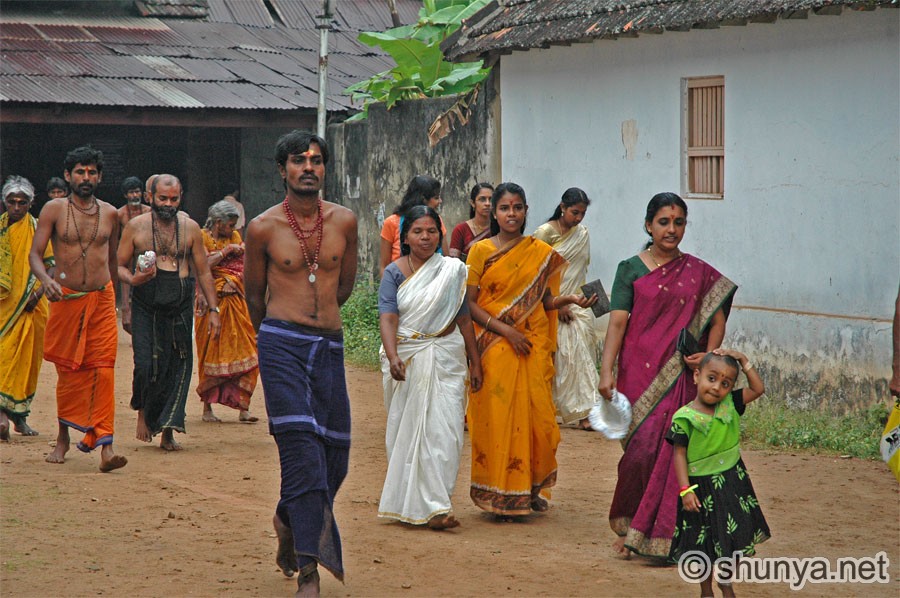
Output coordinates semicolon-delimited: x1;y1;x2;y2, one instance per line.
443;0;897;60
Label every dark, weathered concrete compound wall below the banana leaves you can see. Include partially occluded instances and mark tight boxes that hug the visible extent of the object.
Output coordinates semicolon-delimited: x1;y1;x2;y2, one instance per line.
326;73;500;284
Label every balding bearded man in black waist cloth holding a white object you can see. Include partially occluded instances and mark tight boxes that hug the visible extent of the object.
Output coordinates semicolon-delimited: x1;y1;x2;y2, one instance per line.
118;174;220;451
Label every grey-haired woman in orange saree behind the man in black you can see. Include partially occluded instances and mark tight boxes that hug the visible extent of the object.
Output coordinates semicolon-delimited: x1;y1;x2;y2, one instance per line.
194;200;259;423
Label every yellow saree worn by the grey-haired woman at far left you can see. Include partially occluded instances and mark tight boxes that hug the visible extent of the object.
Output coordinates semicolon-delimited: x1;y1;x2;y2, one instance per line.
0;213;55;418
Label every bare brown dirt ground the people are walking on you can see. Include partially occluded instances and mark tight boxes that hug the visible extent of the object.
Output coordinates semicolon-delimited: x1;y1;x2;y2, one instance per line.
0;324;900;597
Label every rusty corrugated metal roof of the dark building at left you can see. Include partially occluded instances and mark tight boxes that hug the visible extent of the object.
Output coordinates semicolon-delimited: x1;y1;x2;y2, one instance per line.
0;0;421;111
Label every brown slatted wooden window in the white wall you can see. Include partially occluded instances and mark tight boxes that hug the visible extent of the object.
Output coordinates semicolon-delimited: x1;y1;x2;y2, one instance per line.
683;77;725;198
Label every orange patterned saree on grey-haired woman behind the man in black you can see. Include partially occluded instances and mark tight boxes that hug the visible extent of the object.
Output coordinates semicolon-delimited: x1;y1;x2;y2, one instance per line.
194;230;259;410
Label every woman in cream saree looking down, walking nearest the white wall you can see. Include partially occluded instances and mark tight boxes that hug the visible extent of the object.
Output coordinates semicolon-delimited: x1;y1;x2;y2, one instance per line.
534;187;600;430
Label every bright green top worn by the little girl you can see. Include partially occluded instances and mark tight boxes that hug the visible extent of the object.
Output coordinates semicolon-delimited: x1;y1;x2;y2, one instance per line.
666;388;744;477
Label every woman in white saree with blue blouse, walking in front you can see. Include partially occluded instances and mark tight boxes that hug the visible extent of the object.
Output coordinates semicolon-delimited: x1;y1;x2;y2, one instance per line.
378;206;482;529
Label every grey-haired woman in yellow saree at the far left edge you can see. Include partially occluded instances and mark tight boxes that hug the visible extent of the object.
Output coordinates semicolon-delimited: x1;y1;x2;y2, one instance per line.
0;176;55;442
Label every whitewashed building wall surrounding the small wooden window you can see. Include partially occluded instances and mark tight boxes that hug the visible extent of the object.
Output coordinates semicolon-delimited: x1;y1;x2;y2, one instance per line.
500;9;900;406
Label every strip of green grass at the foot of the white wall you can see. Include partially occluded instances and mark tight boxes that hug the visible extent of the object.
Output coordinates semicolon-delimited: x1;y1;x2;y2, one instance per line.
741;399;888;459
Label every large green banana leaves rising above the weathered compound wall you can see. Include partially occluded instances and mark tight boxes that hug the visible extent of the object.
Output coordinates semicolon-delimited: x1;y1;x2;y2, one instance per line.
344;0;490;121
